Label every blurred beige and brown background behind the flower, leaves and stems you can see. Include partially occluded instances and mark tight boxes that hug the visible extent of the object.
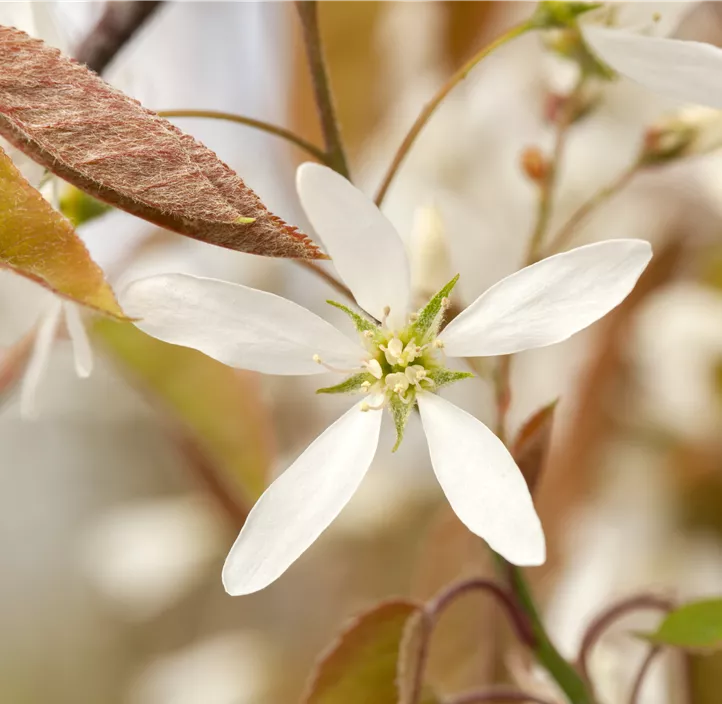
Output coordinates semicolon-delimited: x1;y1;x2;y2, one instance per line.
0;0;722;704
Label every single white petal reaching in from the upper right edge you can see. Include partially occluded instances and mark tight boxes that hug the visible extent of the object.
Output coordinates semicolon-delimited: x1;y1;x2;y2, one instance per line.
583;26;722;108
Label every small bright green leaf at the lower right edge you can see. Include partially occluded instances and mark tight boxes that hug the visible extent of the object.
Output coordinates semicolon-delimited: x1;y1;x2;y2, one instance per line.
639;599;722;650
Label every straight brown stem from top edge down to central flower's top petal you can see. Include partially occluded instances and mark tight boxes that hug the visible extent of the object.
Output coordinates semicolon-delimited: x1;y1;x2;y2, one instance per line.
296;0;350;178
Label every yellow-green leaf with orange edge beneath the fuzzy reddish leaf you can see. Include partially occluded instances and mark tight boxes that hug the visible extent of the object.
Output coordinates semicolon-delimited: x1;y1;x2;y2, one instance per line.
0;150;125;318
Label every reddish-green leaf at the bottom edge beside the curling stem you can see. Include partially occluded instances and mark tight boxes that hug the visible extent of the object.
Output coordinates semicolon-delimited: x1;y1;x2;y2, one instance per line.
303;600;420;704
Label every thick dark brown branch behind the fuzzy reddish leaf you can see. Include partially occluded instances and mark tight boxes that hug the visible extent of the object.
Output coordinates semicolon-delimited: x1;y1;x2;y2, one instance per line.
75;0;163;73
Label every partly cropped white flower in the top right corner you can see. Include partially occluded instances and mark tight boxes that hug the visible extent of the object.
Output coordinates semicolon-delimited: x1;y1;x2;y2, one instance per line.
580;0;722;108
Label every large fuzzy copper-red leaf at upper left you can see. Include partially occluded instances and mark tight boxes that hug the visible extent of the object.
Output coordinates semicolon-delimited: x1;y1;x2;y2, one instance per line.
0;27;323;259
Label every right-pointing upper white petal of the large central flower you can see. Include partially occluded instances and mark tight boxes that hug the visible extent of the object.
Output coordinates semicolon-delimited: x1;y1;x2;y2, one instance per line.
439;240;652;357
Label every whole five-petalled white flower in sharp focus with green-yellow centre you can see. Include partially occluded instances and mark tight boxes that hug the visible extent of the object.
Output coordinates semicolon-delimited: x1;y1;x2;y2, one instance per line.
121;164;651;595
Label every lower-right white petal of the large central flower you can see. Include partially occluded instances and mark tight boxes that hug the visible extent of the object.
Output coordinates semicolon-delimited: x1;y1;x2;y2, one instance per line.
418;392;546;565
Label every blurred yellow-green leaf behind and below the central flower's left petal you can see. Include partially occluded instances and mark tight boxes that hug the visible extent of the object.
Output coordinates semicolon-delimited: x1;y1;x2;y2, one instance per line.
94;320;273;507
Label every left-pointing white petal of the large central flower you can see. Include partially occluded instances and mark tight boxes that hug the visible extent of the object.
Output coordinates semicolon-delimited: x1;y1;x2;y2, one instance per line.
120;274;367;374
